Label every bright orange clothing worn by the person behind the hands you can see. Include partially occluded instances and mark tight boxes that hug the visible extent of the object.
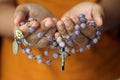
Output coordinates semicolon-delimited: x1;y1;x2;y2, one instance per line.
1;0;120;80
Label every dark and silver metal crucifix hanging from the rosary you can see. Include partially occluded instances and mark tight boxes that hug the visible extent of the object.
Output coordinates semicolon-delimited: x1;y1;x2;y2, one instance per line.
59;48;70;71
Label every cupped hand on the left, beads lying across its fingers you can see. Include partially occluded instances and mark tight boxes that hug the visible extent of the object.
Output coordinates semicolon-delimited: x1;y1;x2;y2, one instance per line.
14;4;56;48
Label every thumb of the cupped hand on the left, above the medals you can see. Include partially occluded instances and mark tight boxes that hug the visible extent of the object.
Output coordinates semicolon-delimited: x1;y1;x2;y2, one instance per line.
14;5;29;25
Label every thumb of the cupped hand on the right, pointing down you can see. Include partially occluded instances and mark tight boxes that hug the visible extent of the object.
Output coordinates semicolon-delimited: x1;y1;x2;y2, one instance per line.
92;4;104;26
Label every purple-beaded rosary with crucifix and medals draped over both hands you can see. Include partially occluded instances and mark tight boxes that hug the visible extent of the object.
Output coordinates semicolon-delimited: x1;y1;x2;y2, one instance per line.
13;14;101;71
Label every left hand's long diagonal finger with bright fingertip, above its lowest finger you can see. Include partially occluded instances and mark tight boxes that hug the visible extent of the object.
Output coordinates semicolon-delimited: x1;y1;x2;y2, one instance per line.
26;18;55;45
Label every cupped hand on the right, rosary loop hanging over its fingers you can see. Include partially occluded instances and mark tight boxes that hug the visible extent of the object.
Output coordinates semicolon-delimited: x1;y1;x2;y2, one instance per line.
57;2;104;46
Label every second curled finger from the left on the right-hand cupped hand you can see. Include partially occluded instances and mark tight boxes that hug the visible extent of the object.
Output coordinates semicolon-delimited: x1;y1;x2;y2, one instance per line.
61;17;74;35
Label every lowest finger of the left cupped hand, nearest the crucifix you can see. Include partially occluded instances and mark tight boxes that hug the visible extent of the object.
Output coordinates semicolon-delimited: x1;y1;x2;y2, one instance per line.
35;28;56;48
